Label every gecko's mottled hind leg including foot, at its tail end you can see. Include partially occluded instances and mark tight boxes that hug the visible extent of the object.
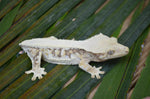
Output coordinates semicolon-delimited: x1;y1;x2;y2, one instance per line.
25;48;46;81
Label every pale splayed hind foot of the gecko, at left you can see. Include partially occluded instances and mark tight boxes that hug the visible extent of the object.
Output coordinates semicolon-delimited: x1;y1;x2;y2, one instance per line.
25;68;47;81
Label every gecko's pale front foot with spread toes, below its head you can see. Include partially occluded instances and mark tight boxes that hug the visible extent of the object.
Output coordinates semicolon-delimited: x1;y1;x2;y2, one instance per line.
90;66;105;79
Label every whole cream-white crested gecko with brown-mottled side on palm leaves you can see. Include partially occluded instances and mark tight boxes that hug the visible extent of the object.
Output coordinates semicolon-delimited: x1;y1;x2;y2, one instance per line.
19;33;129;81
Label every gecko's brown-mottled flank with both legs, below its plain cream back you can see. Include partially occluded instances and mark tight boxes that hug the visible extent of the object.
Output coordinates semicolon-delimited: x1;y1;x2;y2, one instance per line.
26;47;104;81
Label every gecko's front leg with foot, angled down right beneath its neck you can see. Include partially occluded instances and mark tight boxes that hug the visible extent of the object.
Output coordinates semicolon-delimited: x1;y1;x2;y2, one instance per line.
79;59;105;79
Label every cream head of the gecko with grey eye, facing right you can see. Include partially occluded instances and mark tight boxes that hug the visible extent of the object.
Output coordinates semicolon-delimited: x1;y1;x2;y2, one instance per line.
99;37;129;60
